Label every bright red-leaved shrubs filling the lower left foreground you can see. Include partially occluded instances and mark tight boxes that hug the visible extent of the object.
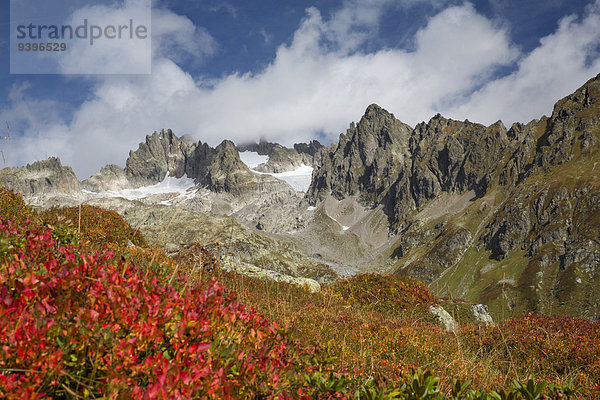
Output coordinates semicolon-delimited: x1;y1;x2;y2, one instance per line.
0;224;324;399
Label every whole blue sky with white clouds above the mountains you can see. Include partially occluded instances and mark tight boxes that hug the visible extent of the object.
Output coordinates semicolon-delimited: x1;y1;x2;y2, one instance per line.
0;0;600;179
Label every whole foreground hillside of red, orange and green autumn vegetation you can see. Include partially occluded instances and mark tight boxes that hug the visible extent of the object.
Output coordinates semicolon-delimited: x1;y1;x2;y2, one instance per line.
0;188;600;399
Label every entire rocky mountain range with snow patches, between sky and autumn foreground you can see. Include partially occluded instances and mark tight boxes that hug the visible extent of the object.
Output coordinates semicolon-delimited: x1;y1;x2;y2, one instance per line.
0;75;600;319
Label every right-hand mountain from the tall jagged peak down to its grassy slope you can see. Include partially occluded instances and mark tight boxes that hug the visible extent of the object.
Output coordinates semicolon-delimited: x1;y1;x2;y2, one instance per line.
332;75;600;319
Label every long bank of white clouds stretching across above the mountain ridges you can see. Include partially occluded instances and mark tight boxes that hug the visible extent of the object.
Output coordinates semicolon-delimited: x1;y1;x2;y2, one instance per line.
0;0;600;178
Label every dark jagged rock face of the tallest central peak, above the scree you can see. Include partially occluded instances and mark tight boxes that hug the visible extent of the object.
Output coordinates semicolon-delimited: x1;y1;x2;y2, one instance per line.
307;104;509;227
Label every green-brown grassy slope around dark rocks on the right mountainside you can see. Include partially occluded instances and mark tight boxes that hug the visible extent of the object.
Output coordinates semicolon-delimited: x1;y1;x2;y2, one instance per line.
394;133;600;320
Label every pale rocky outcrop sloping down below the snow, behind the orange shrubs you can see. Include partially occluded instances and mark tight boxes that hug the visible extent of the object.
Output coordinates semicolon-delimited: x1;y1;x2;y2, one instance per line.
91;198;338;287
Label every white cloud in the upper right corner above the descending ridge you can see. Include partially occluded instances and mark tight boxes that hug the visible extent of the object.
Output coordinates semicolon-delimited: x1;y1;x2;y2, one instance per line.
450;1;600;124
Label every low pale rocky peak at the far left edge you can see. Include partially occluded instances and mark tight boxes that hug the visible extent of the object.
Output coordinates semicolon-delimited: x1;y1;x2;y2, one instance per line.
0;157;81;197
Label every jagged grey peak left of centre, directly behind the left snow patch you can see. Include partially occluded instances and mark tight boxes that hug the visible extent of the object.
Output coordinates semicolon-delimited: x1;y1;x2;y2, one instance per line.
125;129;200;186
